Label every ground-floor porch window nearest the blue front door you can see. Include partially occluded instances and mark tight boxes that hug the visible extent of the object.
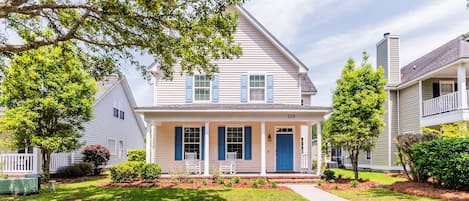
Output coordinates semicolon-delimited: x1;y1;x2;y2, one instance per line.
226;127;244;159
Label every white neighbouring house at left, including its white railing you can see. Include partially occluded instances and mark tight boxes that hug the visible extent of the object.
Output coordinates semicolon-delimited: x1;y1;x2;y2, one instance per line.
0;76;145;173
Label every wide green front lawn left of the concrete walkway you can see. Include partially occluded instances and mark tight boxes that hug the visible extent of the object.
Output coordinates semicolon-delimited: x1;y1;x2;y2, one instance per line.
0;179;305;201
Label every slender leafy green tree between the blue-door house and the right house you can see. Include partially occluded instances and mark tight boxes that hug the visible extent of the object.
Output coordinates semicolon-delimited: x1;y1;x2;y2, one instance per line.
325;52;386;180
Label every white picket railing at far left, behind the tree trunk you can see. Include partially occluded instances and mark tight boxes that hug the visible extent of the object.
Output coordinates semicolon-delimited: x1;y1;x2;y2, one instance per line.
0;153;73;173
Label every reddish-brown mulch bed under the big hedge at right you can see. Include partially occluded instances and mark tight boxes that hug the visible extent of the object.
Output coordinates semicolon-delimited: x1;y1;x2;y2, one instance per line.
387;181;469;201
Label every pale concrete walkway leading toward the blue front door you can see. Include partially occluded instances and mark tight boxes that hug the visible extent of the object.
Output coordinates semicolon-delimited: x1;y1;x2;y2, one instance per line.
284;184;347;201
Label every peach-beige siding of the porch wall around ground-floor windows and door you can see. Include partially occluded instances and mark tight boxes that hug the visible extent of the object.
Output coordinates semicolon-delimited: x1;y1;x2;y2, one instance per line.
155;122;301;173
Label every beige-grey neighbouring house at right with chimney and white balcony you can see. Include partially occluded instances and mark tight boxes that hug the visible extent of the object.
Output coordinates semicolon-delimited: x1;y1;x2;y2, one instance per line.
345;33;469;170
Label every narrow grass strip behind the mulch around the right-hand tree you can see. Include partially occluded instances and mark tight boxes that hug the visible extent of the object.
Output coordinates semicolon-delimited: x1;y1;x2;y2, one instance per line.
332;169;407;185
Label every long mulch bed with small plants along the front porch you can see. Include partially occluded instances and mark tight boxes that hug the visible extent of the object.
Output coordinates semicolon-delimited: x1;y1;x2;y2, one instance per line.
97;179;291;191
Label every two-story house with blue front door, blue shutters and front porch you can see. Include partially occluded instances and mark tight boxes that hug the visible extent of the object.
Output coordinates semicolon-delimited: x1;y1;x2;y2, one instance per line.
136;8;330;175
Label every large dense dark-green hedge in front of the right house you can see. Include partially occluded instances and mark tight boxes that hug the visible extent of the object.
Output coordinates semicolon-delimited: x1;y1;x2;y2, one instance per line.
411;138;469;190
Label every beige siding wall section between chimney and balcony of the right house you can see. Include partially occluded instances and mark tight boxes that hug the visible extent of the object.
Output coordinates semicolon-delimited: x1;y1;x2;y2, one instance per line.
399;84;420;134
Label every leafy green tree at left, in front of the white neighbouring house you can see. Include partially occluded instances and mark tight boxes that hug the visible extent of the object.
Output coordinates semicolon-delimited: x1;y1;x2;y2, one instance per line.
0;42;96;179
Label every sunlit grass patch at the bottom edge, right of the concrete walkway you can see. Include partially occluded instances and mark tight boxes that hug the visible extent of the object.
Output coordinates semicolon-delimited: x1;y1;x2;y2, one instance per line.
331;188;439;201
